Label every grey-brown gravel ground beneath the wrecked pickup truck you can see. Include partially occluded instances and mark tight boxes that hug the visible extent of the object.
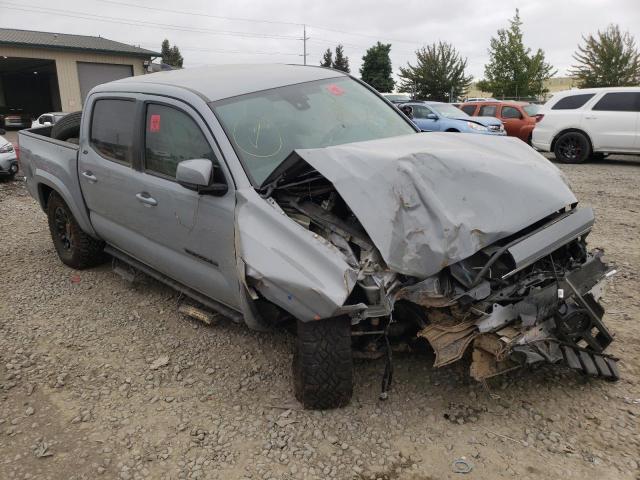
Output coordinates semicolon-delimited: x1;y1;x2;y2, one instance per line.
0;159;640;480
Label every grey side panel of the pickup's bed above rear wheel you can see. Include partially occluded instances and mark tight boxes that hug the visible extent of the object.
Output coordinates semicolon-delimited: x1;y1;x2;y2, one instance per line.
18;127;95;235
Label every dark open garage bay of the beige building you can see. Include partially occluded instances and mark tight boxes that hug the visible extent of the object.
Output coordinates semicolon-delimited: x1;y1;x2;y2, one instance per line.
0;56;62;122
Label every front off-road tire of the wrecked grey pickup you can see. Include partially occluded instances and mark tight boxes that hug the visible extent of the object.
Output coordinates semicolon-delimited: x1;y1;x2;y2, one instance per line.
293;317;353;410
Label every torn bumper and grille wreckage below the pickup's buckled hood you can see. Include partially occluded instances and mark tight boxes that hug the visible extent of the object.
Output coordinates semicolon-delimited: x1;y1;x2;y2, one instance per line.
404;208;619;380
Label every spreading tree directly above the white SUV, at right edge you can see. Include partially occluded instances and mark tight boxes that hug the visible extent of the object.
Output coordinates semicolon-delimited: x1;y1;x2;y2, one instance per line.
569;25;640;88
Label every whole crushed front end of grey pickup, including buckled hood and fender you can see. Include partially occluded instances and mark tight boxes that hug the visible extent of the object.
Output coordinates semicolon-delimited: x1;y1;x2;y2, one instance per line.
236;134;618;381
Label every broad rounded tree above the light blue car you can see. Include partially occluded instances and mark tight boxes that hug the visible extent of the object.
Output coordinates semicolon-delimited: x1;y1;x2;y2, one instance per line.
399;42;473;101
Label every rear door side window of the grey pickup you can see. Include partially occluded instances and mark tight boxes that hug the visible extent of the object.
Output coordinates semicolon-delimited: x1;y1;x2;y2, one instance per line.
89;99;136;165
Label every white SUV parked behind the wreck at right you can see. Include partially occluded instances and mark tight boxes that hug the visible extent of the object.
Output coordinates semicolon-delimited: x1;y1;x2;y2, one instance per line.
531;87;640;163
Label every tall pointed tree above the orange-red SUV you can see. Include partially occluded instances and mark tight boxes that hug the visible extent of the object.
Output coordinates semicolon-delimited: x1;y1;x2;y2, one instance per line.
478;9;556;97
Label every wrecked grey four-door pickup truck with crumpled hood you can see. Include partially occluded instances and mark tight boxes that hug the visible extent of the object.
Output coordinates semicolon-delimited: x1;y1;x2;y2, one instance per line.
20;65;618;408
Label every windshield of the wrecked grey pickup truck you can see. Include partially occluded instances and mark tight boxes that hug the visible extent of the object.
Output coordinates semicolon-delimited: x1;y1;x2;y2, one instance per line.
211;77;416;185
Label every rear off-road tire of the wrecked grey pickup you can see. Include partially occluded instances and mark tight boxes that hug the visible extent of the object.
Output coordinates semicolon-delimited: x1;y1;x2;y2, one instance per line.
47;193;105;270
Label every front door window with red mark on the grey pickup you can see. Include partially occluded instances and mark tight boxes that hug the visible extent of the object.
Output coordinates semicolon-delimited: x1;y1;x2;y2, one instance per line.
144;104;215;178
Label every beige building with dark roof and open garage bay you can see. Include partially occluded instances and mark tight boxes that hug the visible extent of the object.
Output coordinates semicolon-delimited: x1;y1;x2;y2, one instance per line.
0;28;160;117
